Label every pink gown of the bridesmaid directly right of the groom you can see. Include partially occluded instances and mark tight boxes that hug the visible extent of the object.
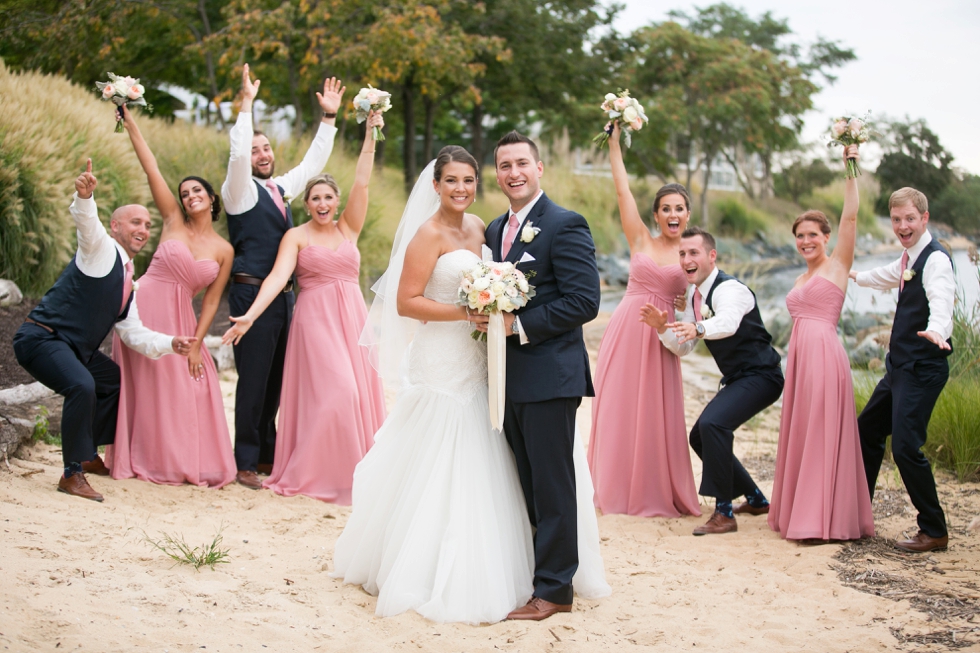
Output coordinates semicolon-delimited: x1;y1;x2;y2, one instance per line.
589;254;701;517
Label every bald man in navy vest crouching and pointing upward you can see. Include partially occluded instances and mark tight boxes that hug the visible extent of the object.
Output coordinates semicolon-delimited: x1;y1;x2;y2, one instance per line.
14;159;197;501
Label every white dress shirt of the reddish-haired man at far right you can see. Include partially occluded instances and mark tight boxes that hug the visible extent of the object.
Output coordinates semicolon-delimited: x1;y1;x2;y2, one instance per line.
855;231;956;340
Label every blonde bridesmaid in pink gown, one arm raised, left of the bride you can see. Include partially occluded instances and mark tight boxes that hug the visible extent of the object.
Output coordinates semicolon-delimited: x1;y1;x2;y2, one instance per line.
224;114;385;505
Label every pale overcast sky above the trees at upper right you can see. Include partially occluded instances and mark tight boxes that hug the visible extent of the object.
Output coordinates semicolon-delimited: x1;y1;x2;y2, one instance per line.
616;0;980;174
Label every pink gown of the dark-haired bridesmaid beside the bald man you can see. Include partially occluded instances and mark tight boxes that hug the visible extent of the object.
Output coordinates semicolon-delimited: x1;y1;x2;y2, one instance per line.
106;240;237;487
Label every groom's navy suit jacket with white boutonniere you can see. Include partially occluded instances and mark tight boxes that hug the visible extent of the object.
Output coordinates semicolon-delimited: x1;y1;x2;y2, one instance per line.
486;194;599;403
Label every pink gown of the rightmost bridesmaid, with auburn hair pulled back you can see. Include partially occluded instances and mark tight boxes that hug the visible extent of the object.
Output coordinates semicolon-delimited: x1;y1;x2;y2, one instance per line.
769;277;874;540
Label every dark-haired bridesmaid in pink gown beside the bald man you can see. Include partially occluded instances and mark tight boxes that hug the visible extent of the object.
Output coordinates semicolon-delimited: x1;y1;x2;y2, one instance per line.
106;108;236;487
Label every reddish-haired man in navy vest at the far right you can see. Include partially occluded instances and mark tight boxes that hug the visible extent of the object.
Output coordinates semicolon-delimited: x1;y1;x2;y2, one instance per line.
851;188;956;552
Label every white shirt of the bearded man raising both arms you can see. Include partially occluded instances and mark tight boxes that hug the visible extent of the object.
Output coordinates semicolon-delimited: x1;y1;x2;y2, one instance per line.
221;111;337;215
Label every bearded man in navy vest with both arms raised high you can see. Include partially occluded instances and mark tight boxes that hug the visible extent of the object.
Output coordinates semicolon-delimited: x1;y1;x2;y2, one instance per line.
221;64;346;490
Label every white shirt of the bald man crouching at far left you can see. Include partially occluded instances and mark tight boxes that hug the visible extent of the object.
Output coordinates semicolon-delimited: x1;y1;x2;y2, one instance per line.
68;193;174;358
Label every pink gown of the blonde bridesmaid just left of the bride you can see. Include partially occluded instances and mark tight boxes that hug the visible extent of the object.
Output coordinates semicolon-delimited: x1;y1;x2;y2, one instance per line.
263;240;385;506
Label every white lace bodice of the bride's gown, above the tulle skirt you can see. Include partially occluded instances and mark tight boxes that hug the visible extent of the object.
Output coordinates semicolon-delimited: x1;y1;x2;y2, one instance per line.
408;249;487;400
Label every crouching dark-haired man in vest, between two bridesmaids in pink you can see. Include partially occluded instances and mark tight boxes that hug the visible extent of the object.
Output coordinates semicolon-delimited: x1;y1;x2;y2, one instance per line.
640;227;783;535
